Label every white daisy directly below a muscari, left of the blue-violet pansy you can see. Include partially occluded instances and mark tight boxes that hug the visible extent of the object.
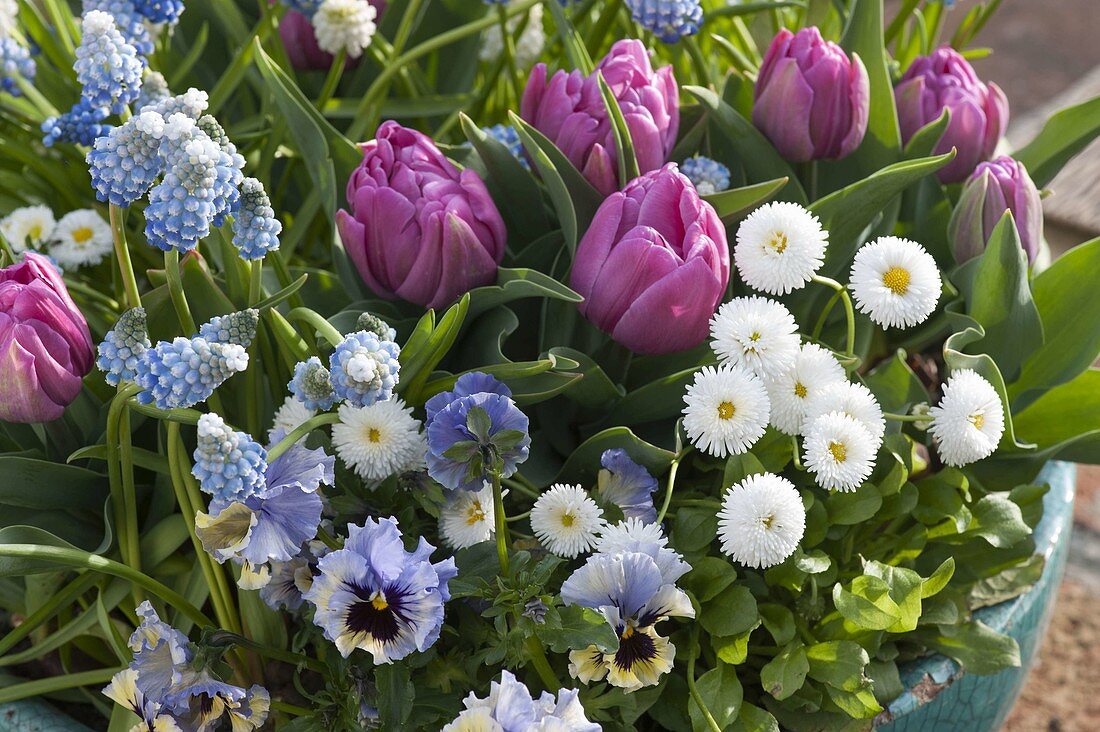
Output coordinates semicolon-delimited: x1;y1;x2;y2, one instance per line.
332;398;425;481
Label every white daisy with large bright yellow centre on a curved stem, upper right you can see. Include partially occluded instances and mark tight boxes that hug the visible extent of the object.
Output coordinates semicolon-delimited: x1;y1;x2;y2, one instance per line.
849;237;943;328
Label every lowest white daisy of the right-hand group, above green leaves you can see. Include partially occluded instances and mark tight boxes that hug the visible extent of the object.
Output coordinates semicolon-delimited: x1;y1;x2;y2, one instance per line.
718;473;806;569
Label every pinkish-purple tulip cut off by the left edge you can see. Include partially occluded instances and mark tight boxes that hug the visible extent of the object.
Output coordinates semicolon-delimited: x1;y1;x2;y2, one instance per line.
0;252;94;423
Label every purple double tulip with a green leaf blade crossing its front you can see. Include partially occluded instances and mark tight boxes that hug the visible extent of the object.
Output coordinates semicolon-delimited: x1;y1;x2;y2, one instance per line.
519;40;680;196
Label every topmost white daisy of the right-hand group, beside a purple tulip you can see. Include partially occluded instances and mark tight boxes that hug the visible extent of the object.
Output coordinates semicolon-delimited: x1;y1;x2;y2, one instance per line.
734;201;828;295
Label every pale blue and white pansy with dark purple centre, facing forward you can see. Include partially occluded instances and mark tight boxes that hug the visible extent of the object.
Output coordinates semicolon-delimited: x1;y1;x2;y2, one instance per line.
304;518;459;664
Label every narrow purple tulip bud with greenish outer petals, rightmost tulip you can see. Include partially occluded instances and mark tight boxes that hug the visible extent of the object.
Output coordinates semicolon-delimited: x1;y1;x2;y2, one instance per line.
947;155;1043;263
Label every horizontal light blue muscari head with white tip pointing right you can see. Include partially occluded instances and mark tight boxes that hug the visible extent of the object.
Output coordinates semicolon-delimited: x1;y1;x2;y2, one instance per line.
134;336;249;409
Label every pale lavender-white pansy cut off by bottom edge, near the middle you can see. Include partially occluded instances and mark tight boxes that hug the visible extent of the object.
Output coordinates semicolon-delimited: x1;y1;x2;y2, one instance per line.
442;670;602;732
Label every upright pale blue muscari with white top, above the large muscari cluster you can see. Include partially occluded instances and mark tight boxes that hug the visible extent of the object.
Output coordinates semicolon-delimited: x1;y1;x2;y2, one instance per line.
73;10;145;114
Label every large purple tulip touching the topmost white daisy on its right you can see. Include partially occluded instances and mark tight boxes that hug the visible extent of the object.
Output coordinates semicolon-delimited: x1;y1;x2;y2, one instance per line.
570;163;729;353
